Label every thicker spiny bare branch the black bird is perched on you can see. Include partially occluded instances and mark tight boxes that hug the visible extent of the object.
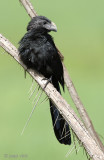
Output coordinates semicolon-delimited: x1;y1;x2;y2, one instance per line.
0;34;104;160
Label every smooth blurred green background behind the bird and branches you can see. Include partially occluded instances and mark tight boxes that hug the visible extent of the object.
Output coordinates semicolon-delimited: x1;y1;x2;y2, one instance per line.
0;0;104;160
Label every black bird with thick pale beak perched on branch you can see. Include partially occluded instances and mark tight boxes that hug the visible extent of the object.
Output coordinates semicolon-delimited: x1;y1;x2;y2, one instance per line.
18;16;71;145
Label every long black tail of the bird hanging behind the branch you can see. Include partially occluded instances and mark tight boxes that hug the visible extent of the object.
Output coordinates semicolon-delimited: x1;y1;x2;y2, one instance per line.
50;78;71;145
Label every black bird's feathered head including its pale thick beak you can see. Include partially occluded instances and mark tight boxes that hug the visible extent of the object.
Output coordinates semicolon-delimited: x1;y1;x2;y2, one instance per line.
27;16;57;32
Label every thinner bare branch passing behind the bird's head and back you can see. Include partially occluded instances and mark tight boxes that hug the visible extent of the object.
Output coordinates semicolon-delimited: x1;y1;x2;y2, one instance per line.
20;0;104;152
